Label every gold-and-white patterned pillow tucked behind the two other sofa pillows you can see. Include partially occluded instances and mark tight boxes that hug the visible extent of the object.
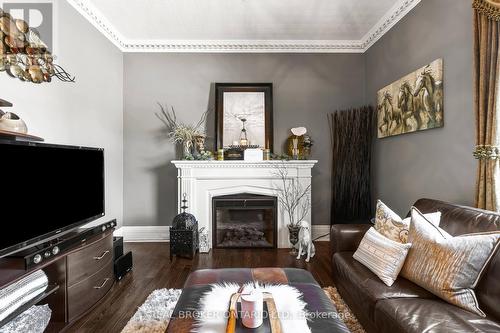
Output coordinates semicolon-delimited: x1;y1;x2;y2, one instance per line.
375;200;441;243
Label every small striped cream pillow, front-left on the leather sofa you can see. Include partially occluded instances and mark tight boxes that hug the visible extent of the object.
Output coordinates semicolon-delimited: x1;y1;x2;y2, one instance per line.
353;228;411;287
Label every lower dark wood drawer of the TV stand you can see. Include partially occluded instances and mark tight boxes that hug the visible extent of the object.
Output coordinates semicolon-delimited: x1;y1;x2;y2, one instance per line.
68;257;115;322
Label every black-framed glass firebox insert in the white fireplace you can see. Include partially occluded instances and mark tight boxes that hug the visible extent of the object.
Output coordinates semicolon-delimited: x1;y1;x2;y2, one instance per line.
212;194;277;248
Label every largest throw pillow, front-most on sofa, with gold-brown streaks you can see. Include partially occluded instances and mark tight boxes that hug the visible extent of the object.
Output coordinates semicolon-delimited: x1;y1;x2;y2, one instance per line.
401;208;500;317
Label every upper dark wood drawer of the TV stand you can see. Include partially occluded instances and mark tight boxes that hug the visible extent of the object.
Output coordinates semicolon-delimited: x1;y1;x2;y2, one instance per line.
68;233;113;288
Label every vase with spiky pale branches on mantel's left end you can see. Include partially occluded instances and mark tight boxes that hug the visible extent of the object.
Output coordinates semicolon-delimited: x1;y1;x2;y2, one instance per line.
155;103;208;159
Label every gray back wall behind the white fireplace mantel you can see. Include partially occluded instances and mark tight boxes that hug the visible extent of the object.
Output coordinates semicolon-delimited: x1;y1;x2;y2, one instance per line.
124;54;365;225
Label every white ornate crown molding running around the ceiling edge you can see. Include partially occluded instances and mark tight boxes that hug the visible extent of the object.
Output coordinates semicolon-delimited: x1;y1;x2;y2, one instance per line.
67;0;422;53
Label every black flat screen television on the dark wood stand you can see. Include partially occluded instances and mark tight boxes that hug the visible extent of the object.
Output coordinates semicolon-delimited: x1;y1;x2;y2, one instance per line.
0;141;104;257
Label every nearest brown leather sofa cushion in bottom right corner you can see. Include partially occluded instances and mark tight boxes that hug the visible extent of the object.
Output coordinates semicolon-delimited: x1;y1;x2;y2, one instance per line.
375;298;500;333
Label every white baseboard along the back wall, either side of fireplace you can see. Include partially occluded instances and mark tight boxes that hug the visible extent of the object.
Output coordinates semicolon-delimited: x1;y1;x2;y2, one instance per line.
115;225;330;242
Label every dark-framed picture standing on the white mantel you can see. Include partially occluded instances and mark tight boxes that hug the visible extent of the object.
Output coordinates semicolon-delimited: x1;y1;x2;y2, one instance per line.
215;83;273;151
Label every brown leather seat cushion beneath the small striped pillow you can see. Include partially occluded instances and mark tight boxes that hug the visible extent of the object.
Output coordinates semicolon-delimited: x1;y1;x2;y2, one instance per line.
333;252;436;320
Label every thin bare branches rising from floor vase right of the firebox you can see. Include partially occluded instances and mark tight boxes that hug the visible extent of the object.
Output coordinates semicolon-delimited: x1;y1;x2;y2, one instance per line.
273;164;311;227
